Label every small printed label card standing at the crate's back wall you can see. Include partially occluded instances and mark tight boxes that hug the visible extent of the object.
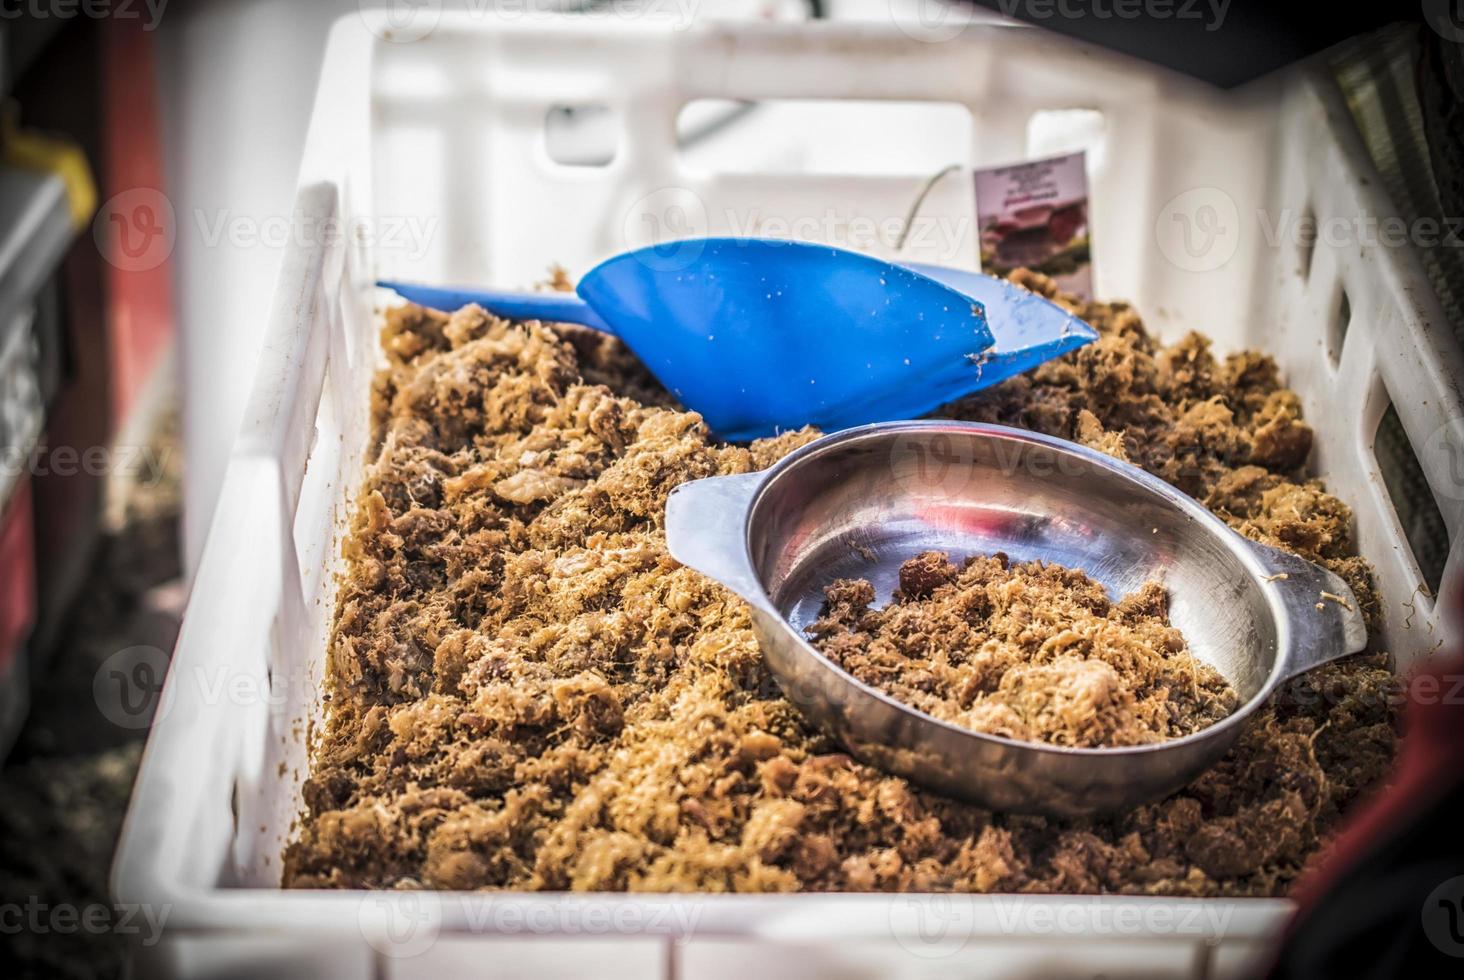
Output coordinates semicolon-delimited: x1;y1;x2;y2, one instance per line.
976;152;1092;297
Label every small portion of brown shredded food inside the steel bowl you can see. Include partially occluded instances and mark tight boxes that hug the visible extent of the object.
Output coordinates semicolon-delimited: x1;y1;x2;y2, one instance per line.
810;551;1237;749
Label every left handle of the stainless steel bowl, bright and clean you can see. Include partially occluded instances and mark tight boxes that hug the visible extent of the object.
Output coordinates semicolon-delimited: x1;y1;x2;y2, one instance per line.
666;473;774;612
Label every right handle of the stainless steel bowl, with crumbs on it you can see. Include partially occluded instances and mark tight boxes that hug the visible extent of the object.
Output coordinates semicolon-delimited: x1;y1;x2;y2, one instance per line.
1246;541;1367;678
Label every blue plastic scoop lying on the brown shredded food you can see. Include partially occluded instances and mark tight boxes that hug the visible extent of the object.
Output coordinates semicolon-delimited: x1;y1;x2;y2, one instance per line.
379;239;1097;439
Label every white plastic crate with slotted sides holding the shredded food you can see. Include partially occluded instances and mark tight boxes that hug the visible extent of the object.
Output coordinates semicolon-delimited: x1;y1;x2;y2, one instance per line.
116;15;1464;977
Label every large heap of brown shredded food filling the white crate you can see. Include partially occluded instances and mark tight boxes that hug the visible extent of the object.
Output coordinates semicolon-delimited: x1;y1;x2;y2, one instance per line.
284;271;1395;895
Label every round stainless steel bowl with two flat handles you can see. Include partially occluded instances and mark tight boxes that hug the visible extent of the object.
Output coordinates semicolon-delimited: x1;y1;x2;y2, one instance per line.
666;422;1367;816
